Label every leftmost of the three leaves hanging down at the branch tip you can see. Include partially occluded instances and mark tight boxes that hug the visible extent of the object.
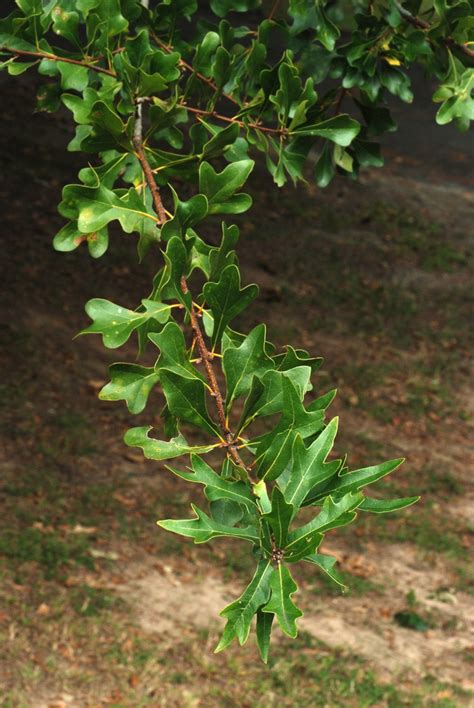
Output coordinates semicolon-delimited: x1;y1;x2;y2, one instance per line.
215;560;273;653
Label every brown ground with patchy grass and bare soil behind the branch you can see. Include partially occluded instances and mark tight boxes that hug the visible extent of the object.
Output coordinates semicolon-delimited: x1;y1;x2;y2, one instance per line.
0;70;474;708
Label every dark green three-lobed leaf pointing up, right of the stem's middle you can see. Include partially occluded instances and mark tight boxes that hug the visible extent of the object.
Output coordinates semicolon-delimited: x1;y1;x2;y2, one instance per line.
203;265;258;347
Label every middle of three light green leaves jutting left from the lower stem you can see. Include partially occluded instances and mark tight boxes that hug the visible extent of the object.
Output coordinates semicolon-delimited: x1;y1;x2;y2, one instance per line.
99;363;158;414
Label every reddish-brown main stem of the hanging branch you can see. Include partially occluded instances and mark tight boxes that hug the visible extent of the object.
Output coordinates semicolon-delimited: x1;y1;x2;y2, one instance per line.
133;127;254;479
